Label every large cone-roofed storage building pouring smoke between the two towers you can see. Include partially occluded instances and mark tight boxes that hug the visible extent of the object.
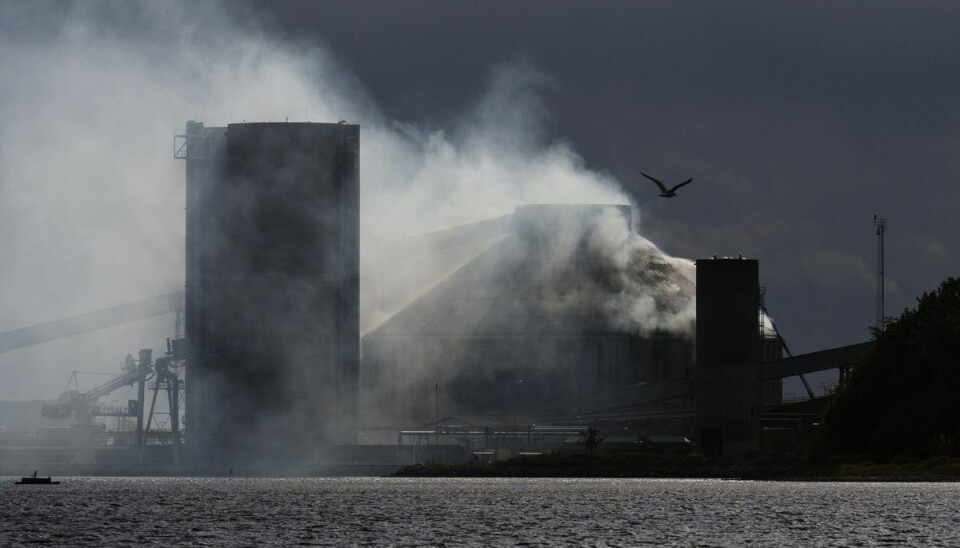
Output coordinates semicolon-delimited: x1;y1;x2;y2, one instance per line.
361;205;693;434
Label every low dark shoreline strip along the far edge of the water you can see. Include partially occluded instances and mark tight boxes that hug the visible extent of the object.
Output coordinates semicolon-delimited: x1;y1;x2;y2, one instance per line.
7;453;960;483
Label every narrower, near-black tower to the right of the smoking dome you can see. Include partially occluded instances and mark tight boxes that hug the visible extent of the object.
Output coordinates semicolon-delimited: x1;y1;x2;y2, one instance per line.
694;259;760;456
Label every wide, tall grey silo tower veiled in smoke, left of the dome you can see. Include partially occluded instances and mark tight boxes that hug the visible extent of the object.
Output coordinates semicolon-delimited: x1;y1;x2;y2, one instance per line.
178;122;360;463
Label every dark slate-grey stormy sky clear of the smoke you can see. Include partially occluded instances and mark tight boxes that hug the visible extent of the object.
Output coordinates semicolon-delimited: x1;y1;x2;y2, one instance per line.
249;0;960;351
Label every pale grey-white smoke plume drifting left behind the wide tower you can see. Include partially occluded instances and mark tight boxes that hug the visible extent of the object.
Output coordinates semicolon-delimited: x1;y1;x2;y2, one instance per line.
0;2;689;399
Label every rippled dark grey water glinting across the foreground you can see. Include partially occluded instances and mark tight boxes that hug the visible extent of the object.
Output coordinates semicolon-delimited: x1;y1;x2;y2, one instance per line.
0;478;960;546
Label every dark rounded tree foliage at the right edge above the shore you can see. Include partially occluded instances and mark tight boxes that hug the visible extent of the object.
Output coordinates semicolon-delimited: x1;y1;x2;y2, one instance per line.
825;278;960;458
